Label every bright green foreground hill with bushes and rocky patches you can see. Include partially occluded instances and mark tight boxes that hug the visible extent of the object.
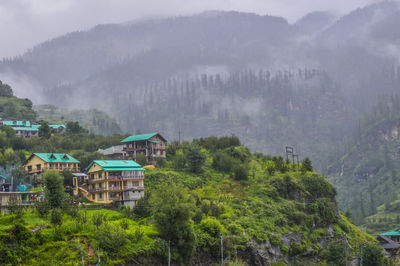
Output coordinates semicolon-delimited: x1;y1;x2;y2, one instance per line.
0;135;382;265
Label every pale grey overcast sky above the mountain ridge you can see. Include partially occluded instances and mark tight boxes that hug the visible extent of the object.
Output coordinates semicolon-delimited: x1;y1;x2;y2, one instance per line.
0;0;377;58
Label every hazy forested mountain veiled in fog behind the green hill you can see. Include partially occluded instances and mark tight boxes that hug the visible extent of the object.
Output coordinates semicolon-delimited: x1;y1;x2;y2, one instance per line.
0;1;400;168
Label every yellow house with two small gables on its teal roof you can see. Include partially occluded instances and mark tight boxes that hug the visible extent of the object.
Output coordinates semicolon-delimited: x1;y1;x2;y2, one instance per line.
24;153;79;183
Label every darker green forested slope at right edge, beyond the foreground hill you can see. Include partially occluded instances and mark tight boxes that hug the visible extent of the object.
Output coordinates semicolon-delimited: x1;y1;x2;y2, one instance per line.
328;96;400;233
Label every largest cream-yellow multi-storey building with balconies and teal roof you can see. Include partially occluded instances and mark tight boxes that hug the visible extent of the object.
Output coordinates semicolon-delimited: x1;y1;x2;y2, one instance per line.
78;160;145;208
